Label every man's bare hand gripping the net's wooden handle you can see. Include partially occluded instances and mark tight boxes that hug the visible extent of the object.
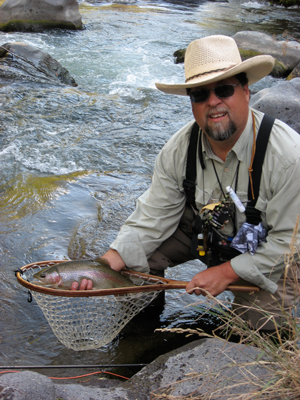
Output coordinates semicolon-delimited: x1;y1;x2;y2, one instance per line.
186;261;240;296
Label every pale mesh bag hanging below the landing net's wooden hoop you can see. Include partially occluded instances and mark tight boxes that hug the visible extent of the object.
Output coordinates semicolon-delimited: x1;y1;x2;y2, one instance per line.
22;264;159;351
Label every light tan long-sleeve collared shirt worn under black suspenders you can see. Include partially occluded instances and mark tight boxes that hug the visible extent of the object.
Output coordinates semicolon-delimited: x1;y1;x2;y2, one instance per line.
111;109;300;293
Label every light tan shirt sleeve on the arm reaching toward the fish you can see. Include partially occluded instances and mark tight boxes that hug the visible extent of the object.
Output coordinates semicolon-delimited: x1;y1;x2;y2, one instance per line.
110;124;192;272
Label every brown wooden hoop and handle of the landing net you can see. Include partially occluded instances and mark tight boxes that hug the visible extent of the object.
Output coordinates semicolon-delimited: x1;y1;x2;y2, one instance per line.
16;260;260;297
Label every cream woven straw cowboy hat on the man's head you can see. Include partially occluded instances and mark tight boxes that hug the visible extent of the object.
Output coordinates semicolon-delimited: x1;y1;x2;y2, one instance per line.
155;35;275;96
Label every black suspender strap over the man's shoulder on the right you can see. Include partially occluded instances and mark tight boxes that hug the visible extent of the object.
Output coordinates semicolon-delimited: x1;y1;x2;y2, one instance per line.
245;114;275;225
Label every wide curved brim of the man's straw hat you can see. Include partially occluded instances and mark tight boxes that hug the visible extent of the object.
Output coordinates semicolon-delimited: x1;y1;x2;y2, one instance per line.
155;55;275;96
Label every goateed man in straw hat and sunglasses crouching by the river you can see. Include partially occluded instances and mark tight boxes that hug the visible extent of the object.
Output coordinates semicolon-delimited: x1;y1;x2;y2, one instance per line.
74;35;300;330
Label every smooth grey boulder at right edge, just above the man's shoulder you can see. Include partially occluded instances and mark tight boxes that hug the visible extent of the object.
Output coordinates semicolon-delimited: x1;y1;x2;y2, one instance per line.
250;78;300;133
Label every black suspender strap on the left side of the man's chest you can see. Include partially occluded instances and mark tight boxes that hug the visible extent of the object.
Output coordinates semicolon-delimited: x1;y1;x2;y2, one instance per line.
183;122;199;210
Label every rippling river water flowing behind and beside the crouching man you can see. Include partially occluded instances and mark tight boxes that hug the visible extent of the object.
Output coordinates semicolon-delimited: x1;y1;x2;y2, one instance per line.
0;0;300;375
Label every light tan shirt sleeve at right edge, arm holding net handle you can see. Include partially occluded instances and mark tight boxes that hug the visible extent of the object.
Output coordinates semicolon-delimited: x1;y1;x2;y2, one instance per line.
231;121;300;293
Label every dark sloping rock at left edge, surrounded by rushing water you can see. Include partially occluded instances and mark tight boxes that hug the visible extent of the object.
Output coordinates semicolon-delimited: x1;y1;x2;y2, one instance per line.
0;42;77;86
